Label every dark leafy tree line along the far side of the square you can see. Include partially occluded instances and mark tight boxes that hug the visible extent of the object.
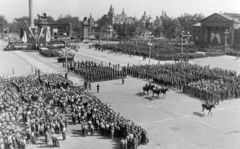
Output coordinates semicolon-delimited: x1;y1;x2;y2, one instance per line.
0;13;204;39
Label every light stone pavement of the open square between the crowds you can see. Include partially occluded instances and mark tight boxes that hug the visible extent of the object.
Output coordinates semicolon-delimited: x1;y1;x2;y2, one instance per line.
0;41;240;149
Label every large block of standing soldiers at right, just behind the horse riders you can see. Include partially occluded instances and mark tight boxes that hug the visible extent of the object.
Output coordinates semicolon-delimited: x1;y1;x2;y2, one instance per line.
126;63;240;103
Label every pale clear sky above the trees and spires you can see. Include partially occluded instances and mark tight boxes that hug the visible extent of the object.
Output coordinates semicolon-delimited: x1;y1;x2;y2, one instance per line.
0;0;240;22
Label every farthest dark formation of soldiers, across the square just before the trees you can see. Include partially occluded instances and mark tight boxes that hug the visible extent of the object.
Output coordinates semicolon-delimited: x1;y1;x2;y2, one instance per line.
93;41;207;61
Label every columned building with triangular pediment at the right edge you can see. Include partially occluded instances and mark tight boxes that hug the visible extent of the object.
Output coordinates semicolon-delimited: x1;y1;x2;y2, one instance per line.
192;13;240;45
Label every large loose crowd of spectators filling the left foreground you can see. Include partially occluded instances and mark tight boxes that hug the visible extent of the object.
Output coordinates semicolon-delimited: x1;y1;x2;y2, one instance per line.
0;73;148;149
